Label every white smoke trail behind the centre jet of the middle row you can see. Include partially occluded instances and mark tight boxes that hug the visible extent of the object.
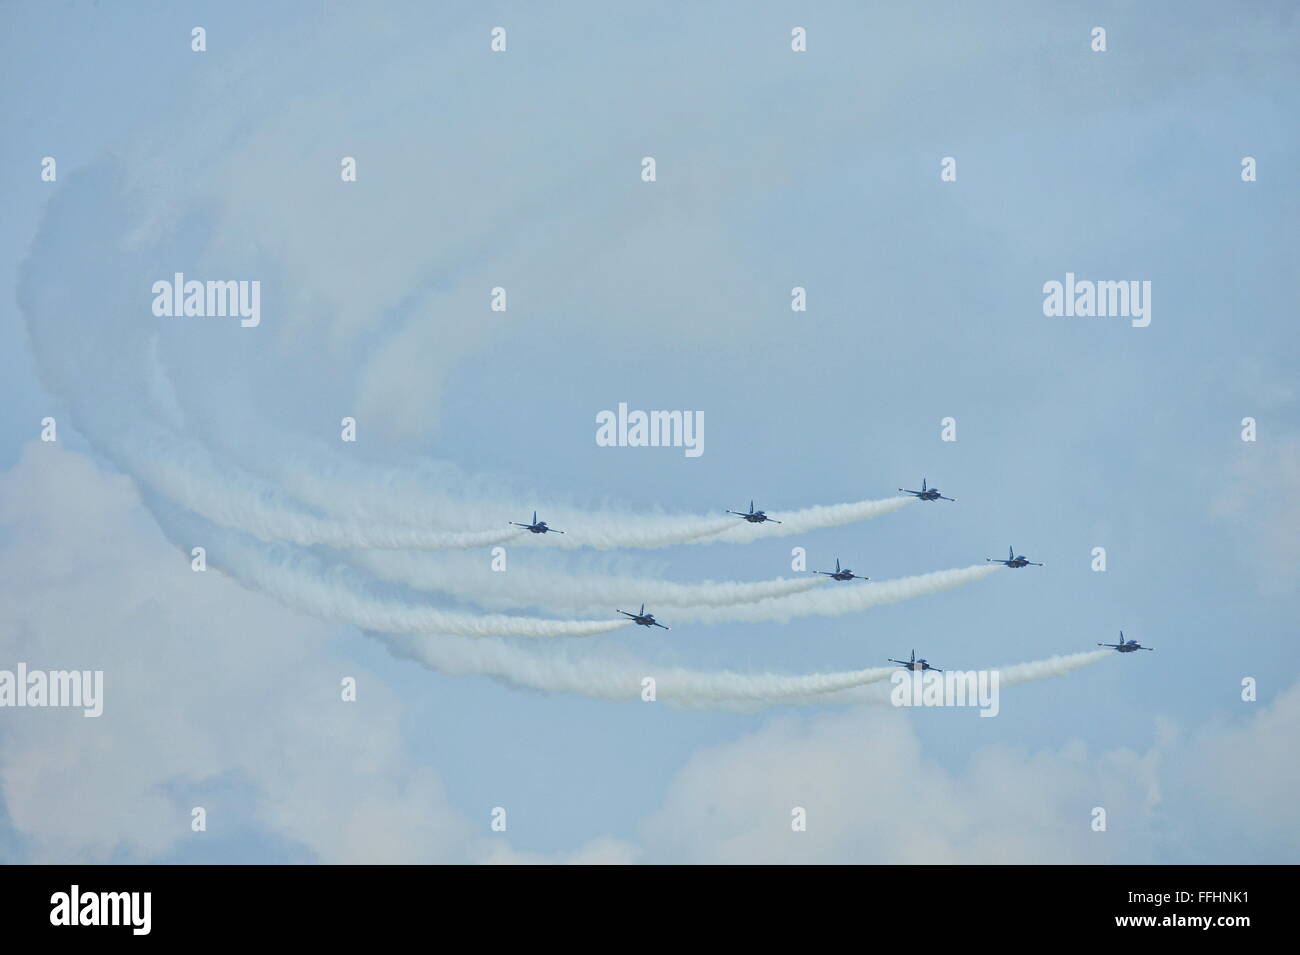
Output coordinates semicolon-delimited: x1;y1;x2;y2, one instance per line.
350;551;826;616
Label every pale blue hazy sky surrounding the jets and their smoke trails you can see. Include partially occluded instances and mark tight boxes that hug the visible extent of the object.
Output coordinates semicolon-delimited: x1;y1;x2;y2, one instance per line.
0;4;1300;863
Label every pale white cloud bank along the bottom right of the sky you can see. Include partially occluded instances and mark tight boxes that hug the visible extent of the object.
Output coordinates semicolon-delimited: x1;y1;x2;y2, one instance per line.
629;685;1300;864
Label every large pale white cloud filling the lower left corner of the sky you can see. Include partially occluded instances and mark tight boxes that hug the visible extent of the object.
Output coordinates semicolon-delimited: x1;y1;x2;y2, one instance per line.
0;443;481;863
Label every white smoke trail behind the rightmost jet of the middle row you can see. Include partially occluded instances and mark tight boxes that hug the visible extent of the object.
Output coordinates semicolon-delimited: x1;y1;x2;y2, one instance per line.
672;564;1002;624
